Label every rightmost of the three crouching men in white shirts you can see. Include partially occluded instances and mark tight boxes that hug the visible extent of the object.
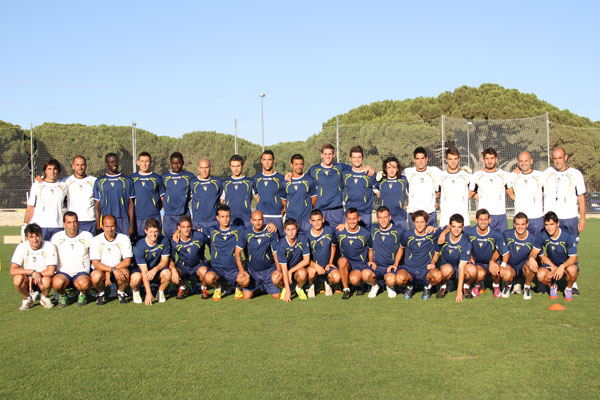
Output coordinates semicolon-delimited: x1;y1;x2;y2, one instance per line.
90;214;133;306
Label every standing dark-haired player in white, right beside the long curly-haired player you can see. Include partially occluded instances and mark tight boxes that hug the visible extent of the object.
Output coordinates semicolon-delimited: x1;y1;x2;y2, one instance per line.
404;147;442;229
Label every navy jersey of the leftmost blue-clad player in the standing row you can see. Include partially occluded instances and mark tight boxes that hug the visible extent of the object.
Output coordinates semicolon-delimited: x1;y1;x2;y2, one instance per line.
94;174;135;218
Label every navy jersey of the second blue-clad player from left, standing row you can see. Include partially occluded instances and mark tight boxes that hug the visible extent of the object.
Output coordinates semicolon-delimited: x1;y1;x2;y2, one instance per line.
131;171;165;219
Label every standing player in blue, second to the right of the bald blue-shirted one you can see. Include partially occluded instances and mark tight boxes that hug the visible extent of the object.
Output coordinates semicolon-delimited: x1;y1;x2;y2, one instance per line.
252;150;286;237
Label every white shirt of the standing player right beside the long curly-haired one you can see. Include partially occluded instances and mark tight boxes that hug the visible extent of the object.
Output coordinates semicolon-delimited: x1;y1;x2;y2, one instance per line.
404;166;442;214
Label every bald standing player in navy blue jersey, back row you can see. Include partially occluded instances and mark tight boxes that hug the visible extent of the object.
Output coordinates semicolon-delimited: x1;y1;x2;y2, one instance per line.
191;158;223;230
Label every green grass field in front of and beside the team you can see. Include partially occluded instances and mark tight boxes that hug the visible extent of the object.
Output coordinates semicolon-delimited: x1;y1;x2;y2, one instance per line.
0;220;600;399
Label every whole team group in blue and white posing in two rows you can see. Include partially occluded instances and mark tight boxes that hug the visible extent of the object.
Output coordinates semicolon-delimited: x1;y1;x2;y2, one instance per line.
11;144;585;310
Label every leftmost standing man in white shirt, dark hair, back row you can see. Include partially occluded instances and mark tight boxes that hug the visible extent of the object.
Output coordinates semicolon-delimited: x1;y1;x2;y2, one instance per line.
23;159;67;240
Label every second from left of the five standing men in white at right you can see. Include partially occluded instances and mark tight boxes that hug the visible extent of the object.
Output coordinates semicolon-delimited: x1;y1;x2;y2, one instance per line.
438;146;471;226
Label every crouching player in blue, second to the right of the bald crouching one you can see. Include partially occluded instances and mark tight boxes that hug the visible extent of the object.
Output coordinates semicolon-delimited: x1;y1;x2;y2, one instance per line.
306;208;340;298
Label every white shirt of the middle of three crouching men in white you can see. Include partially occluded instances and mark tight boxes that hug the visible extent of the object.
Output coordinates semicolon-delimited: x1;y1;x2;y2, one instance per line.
50;231;94;276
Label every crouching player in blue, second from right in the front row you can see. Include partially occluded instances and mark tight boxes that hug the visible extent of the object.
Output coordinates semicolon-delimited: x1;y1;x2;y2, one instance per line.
502;212;542;300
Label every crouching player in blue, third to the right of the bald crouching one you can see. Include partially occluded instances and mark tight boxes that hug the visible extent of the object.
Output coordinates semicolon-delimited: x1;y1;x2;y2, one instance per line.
335;207;376;300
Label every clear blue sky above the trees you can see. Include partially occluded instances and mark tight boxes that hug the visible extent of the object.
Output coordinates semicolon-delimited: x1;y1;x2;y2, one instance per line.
0;0;600;144
